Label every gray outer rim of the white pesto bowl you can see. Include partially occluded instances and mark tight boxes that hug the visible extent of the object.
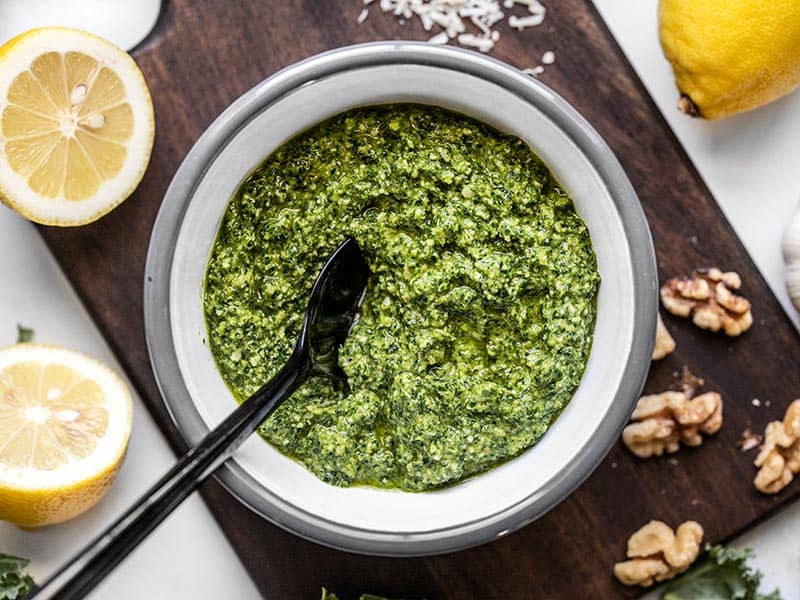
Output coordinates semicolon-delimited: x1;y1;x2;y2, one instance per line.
144;42;658;556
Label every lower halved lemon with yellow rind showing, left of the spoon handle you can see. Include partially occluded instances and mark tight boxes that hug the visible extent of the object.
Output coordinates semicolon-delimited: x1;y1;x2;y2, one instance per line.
0;344;133;528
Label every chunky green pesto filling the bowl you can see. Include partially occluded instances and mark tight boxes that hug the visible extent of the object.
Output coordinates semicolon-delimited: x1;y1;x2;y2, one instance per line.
204;105;600;490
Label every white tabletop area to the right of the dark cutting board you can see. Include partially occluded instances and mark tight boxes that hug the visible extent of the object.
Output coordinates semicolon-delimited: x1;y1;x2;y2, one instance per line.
594;0;800;600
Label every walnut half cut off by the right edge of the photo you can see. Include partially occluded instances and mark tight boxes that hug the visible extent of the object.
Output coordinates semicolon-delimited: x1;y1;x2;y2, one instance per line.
753;399;800;494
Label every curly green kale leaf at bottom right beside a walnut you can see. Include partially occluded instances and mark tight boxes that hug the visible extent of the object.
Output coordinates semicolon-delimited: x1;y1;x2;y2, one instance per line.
662;546;781;600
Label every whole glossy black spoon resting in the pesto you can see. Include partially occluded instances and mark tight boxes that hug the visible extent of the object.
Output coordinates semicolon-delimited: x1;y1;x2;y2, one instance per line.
33;238;370;600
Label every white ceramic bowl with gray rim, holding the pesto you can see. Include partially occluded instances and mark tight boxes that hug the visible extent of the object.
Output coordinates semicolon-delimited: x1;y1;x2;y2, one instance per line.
145;42;657;555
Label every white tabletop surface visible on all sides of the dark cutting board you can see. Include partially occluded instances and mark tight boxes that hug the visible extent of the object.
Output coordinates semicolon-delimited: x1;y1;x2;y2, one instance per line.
0;0;800;600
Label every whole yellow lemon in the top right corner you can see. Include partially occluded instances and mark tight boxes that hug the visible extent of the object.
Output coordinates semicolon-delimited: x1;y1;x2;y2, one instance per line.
658;0;800;119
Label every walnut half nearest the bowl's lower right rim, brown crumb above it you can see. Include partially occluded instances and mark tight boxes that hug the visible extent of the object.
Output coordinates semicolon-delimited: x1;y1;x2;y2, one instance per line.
622;374;722;458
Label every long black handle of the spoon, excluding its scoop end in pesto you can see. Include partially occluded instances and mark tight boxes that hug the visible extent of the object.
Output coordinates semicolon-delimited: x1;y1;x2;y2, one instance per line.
33;354;307;600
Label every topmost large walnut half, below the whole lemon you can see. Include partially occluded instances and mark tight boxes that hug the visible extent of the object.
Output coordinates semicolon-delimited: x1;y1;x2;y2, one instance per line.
661;268;753;336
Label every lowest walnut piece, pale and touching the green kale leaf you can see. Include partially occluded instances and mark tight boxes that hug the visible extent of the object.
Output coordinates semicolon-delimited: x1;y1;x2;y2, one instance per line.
614;521;703;587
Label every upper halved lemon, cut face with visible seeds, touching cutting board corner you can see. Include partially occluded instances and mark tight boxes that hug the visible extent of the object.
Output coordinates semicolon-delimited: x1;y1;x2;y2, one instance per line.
0;27;155;226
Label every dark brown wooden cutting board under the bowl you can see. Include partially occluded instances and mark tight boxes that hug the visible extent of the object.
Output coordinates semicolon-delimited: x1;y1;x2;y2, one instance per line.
34;0;800;600
